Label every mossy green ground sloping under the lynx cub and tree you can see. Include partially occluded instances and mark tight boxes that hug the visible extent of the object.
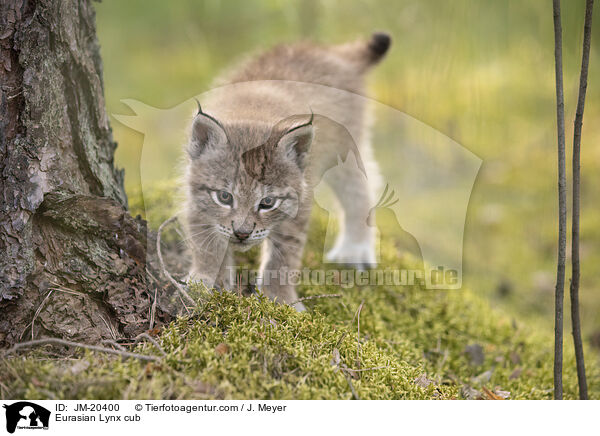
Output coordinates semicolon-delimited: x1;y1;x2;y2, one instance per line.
0;186;600;399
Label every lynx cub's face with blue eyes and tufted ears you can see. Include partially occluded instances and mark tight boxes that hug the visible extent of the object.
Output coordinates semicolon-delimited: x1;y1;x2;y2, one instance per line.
187;111;313;253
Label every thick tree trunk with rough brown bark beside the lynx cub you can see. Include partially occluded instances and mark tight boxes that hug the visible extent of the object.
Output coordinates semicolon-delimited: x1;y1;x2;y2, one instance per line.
0;0;168;346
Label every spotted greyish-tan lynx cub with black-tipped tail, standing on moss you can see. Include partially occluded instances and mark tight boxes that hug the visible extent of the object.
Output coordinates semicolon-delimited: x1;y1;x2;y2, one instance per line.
185;33;390;310
